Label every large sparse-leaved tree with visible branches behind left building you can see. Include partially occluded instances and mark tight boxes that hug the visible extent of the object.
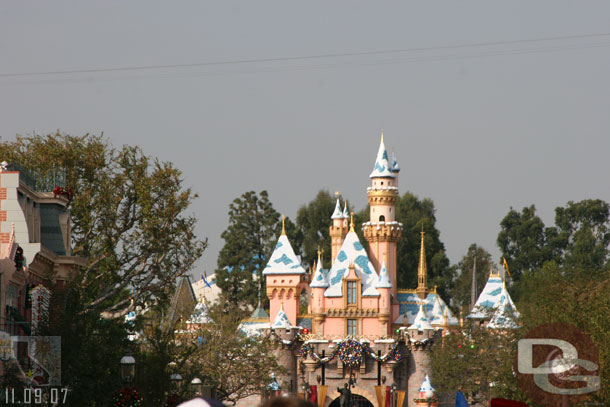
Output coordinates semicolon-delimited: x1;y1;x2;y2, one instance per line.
0;133;206;318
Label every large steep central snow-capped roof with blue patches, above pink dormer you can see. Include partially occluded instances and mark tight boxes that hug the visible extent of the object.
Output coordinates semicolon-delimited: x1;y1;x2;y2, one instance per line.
324;230;379;297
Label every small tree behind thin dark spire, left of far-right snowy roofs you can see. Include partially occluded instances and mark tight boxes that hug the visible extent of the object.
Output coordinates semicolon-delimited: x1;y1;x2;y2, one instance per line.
451;243;492;311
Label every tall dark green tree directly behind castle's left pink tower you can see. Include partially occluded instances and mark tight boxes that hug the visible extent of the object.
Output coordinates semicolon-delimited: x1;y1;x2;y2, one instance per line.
216;191;302;307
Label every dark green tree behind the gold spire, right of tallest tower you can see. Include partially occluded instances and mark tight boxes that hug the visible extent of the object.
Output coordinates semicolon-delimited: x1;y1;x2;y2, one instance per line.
396;192;455;296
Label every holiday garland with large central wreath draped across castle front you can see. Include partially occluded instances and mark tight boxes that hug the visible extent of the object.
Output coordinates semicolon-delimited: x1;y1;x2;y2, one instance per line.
298;339;402;366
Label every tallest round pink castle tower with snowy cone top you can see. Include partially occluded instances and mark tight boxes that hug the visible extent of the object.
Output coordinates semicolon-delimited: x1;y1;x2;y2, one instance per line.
363;132;402;298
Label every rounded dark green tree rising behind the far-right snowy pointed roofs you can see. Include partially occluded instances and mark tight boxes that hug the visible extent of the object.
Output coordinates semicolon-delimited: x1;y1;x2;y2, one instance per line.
497;205;557;281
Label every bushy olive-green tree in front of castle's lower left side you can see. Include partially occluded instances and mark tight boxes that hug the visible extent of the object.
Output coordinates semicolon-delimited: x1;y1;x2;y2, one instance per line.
182;297;286;404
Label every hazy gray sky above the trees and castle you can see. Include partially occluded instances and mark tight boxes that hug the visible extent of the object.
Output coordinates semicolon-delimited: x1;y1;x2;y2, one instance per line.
0;0;610;275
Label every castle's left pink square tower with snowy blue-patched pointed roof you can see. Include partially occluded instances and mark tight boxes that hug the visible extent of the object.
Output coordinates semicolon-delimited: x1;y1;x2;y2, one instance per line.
263;217;308;325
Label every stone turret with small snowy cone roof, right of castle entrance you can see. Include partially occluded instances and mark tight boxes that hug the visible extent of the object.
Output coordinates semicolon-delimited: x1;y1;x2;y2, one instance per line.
407;301;435;407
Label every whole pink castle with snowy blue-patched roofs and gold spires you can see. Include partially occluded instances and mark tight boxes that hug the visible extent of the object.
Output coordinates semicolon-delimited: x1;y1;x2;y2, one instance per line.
249;134;458;407
